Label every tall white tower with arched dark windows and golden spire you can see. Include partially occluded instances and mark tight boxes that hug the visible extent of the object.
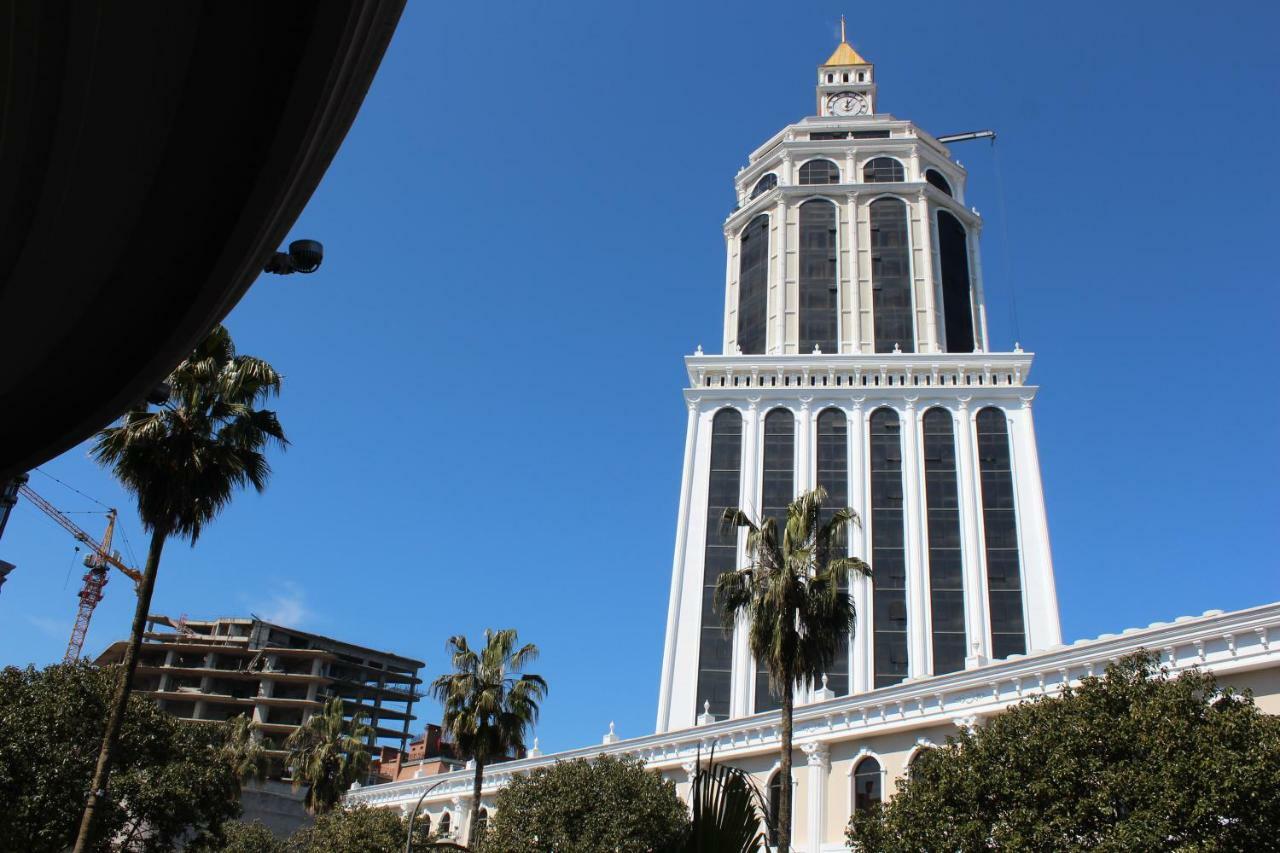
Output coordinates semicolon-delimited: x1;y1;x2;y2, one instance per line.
658;41;1061;733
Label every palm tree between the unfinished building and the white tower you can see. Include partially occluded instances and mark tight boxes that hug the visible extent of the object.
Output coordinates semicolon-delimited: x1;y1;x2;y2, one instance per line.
431;628;547;841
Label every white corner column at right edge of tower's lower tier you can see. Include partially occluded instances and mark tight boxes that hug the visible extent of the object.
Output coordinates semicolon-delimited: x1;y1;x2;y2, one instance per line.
1005;397;1062;652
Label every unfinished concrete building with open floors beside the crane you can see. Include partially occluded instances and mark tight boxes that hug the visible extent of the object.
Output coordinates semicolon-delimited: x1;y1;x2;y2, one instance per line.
96;615;422;776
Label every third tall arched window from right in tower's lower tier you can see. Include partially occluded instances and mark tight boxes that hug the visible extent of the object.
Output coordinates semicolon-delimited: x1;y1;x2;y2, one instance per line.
870;409;908;688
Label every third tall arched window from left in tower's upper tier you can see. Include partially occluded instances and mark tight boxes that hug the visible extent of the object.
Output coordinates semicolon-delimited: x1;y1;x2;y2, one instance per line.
870;199;915;352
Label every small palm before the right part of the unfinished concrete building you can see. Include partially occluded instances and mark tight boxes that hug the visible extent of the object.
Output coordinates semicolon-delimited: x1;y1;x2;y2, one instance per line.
284;695;374;815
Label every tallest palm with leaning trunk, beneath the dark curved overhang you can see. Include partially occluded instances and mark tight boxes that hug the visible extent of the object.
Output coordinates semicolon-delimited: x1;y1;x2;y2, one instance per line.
74;325;288;853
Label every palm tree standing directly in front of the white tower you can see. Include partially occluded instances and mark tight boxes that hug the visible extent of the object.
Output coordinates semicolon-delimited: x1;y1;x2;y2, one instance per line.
716;487;870;853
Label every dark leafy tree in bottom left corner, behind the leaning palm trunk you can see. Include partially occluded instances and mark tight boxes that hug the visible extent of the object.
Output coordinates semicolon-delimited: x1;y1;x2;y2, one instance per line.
0;663;239;853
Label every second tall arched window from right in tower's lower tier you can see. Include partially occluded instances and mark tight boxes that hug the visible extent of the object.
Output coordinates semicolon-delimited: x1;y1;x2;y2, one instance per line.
924;409;965;675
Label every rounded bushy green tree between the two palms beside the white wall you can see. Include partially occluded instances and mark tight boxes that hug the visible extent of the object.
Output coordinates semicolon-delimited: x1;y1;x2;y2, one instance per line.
484;756;689;853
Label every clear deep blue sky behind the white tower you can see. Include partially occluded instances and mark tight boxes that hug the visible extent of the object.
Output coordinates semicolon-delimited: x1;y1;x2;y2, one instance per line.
0;1;1280;749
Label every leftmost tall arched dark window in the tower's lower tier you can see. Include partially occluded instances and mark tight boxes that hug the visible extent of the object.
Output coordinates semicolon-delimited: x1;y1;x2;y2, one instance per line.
696;409;742;719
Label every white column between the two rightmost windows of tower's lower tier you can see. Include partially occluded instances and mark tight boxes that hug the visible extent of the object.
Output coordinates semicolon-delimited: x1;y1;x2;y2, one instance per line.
955;397;991;667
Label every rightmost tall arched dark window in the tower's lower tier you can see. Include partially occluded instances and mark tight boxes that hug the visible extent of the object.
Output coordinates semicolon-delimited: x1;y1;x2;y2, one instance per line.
978;409;1027;660
